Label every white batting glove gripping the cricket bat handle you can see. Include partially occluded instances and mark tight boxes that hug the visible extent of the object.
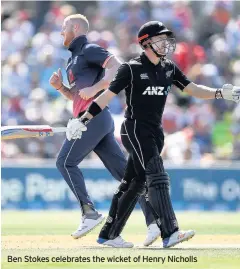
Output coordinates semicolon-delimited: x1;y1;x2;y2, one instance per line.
66;119;87;141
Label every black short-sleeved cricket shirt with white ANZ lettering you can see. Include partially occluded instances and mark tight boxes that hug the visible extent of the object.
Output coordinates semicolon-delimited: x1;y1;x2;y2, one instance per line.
109;53;190;126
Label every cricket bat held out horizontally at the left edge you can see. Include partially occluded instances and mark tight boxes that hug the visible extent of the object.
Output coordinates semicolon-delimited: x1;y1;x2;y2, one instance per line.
1;125;67;140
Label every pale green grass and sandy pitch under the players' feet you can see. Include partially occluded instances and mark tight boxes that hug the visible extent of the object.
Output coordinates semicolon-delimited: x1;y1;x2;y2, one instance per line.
2;211;240;269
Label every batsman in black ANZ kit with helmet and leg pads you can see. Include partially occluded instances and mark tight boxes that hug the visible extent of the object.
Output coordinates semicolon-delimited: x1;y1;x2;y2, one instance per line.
67;21;240;248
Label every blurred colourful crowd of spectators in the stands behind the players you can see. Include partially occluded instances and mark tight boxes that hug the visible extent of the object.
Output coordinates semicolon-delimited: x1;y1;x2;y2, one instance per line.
1;1;240;164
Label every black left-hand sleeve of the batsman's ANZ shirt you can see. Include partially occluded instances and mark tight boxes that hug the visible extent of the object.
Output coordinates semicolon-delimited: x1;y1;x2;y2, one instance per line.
108;63;131;94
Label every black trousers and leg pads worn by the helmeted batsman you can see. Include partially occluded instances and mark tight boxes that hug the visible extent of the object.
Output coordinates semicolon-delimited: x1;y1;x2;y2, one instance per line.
99;119;178;239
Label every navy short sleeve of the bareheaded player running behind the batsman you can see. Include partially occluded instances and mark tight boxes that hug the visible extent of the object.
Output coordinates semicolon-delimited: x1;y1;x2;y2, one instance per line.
84;44;113;68
